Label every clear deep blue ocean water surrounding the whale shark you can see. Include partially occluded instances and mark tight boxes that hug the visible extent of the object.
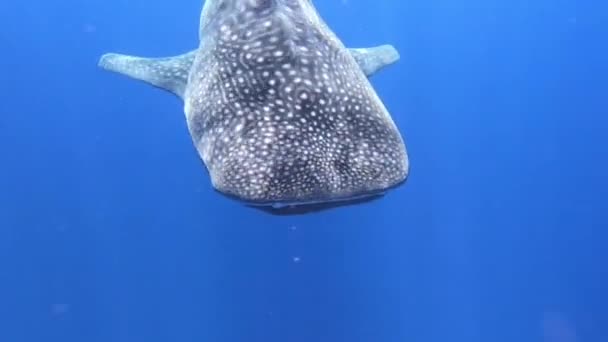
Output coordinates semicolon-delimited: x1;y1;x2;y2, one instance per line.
0;0;608;342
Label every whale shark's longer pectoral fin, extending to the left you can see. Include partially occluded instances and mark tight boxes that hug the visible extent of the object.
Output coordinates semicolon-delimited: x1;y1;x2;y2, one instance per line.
98;50;197;98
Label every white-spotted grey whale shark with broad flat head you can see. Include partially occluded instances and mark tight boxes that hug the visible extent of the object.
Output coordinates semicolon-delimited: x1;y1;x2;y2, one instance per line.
100;0;409;205
